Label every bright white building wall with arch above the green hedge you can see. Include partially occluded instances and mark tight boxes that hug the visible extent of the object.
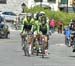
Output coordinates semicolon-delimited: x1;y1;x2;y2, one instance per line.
27;0;59;11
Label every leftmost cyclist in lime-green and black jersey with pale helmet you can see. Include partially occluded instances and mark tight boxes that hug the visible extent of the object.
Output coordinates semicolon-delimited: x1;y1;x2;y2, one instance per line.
21;13;34;49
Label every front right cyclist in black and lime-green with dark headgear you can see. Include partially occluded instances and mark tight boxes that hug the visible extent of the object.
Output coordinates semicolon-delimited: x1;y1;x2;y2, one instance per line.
39;16;49;54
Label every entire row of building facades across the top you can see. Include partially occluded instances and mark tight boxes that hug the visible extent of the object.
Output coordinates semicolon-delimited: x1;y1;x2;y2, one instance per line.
0;0;75;13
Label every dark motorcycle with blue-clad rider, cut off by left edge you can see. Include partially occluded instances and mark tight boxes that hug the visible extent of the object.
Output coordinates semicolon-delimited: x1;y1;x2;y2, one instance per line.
0;16;10;38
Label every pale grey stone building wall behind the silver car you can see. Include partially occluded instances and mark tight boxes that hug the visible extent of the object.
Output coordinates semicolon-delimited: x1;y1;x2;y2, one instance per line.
0;0;28;13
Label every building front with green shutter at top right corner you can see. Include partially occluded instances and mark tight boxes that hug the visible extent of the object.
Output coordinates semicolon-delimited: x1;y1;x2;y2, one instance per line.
58;0;75;13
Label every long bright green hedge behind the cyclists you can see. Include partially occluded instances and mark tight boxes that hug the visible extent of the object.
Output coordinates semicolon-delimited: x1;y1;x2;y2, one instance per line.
25;6;75;26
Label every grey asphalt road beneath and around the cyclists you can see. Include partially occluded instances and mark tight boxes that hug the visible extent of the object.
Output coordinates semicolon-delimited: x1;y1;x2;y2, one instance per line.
0;31;75;66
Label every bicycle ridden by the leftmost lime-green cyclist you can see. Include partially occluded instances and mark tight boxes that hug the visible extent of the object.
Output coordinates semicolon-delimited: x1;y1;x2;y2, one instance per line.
23;32;32;56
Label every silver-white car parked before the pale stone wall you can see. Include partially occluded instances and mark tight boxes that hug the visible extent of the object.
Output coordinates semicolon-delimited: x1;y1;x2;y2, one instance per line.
1;11;17;21
